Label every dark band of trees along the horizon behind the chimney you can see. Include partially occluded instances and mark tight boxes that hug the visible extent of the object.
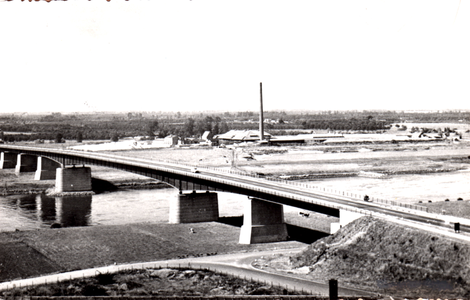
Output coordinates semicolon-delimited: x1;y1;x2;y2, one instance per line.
0;111;470;142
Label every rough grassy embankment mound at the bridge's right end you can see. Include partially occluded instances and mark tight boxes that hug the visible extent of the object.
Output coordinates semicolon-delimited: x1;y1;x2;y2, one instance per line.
289;217;470;297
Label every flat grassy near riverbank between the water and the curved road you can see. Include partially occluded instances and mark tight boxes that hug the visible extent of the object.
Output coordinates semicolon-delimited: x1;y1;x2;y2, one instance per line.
0;222;306;281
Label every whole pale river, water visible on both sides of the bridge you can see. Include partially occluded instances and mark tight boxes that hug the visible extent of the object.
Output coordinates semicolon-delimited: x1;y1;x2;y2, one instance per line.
0;170;470;231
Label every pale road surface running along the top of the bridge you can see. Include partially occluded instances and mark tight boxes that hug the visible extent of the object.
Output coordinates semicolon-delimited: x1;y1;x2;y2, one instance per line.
1;146;470;238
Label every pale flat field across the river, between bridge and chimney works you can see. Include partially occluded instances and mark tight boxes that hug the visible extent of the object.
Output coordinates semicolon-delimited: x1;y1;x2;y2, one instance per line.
102;142;470;177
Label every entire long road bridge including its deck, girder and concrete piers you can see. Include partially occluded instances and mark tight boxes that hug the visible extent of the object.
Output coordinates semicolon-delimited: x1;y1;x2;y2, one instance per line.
0;145;462;244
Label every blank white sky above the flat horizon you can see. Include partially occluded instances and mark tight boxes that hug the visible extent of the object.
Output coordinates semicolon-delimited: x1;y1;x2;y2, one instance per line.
0;0;470;112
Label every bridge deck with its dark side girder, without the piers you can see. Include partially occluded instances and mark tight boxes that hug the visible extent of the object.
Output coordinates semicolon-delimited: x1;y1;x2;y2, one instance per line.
0;145;436;244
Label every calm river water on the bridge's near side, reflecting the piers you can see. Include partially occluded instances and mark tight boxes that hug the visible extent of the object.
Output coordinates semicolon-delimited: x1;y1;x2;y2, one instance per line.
0;188;246;231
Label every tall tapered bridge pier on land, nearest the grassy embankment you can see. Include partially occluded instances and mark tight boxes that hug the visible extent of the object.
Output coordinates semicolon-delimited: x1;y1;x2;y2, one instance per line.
239;198;287;244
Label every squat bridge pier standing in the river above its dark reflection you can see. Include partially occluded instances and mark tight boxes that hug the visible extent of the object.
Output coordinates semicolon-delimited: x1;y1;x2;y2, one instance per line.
55;167;91;193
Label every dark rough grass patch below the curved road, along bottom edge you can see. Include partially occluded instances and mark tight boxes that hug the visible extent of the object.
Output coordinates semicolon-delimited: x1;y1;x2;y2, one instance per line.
5;269;301;297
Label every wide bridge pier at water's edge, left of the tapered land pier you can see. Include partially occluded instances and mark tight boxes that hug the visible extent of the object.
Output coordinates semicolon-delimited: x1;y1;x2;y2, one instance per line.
169;192;219;224
